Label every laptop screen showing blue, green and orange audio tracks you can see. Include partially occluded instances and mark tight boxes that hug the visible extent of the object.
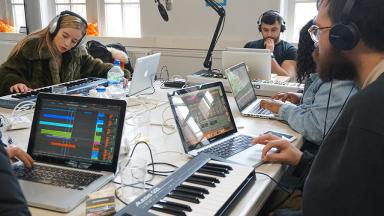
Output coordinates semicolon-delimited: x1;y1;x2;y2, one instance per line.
28;94;126;170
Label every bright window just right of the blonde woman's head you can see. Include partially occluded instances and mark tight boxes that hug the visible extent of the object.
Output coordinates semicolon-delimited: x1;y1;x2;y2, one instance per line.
103;0;141;37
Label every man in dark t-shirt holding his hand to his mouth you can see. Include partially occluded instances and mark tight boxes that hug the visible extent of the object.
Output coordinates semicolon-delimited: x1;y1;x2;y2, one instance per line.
244;10;297;77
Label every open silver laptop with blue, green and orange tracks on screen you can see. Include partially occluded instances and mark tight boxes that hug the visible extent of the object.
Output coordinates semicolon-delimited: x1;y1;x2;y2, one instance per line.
13;93;126;212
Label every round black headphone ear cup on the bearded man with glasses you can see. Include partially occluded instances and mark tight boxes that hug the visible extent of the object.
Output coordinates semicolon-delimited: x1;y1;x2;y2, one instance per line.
329;23;360;50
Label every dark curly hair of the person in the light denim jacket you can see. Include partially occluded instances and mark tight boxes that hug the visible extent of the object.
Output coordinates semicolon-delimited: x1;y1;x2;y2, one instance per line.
297;19;316;83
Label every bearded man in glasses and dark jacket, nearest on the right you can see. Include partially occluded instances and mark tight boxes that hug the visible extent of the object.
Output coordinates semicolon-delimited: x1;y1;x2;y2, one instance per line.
253;0;384;216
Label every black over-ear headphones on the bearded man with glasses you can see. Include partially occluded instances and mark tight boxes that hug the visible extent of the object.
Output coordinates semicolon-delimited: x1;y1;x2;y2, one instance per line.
329;0;360;50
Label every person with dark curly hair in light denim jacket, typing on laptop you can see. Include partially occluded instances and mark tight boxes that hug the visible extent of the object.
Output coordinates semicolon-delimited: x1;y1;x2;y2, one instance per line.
260;20;358;146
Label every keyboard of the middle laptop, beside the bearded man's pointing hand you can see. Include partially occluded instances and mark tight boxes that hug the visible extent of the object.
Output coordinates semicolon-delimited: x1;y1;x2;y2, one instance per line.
201;135;253;158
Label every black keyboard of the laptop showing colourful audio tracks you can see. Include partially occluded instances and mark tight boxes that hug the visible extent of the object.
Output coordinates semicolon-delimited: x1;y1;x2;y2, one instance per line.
13;164;102;190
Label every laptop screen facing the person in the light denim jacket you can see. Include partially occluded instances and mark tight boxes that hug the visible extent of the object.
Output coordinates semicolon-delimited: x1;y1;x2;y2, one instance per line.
225;63;257;111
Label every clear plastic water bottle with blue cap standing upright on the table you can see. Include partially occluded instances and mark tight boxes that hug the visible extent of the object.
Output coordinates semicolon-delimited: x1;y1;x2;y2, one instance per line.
107;59;125;98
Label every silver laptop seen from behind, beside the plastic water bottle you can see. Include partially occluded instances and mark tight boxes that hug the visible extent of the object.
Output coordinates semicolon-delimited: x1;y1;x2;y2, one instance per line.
127;53;160;96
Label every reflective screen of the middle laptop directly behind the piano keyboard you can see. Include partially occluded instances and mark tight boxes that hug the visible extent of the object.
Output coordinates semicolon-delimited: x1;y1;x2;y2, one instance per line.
168;82;237;152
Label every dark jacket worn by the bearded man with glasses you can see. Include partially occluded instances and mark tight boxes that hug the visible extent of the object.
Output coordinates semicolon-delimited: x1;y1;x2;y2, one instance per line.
298;74;384;216
